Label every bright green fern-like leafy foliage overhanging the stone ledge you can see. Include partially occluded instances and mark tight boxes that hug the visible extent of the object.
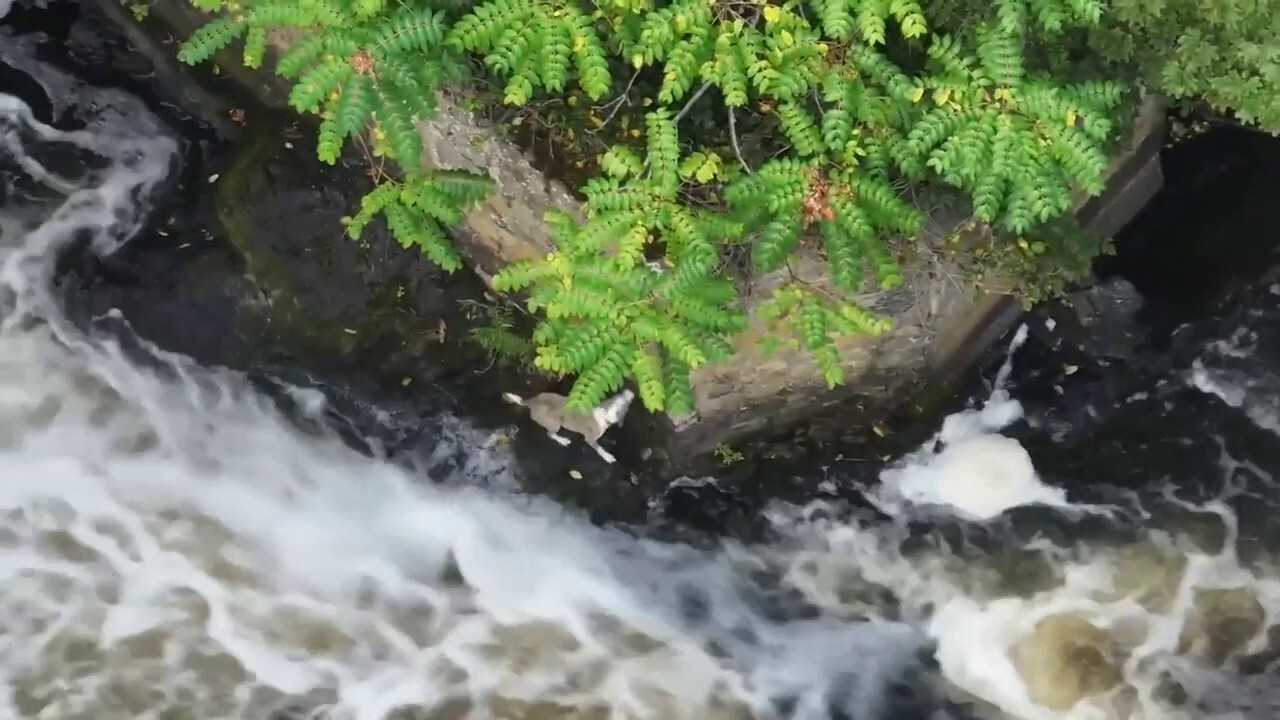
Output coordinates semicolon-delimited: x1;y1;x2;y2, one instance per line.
172;0;1280;413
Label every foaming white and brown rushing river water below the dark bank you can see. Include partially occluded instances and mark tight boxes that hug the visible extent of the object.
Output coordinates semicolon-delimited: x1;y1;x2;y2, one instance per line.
0;47;1280;720
